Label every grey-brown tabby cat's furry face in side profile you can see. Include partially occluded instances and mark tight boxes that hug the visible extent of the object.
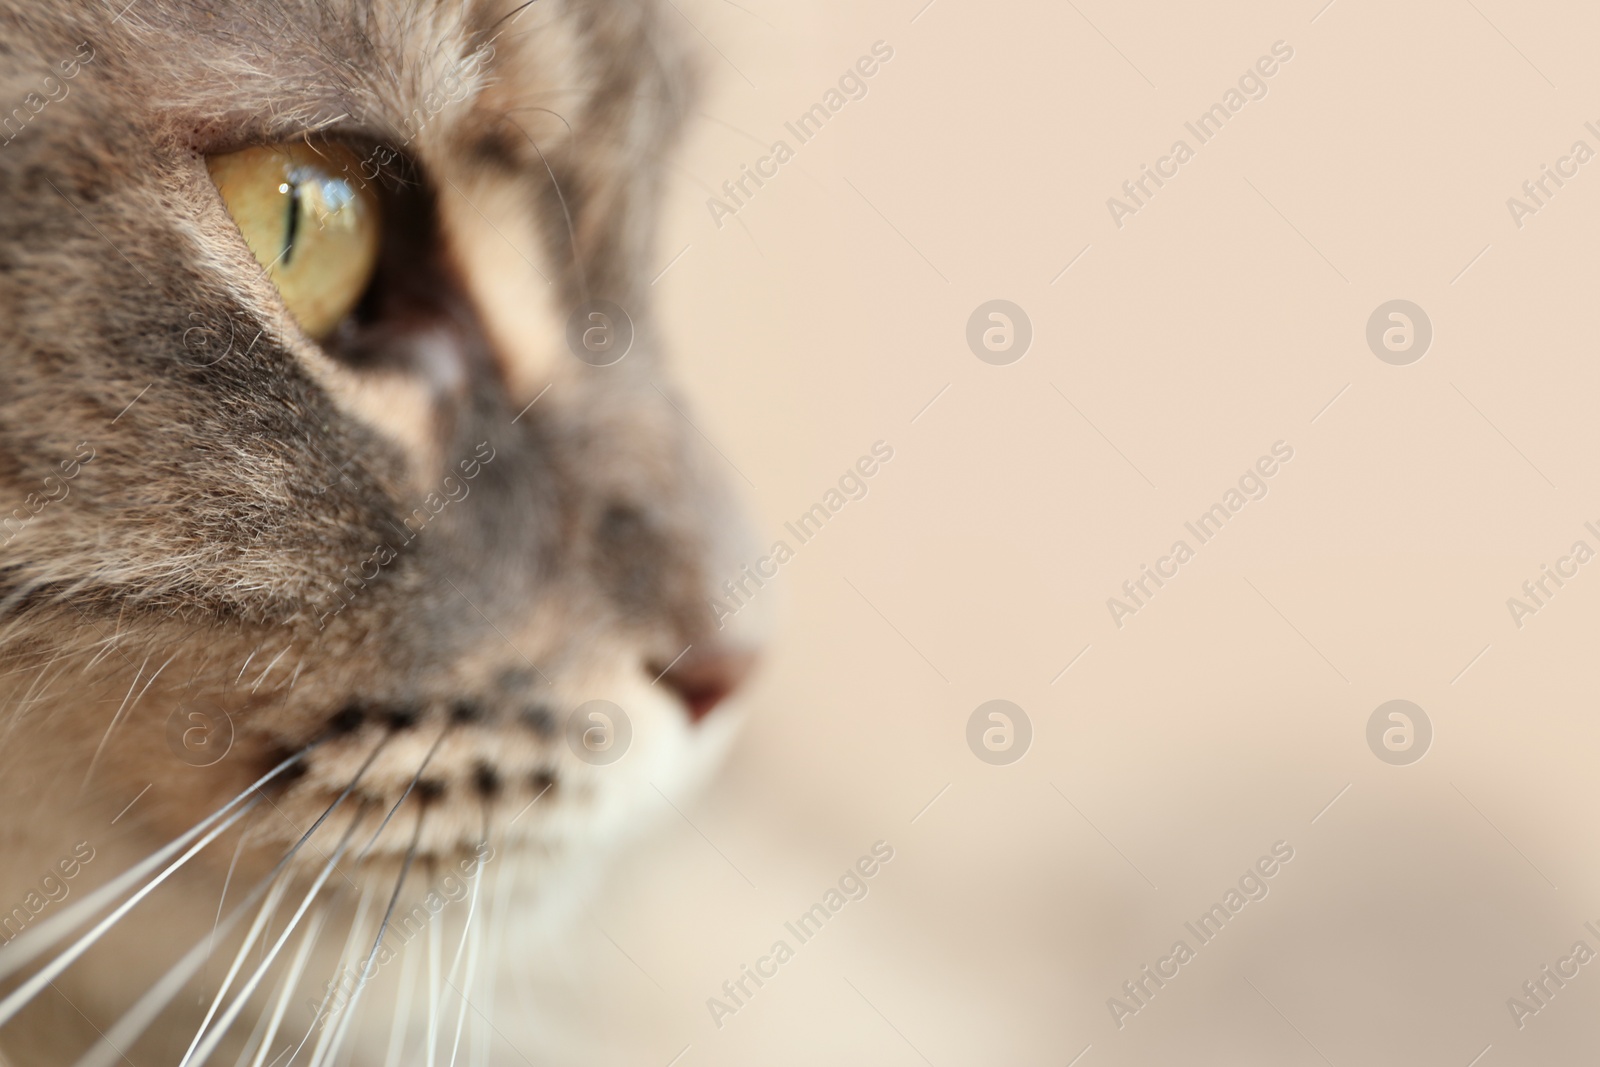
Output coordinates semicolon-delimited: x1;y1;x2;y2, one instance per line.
0;0;750;1048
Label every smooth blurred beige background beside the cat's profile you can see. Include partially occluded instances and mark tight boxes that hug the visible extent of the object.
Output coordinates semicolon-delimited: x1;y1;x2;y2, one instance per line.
523;0;1600;1067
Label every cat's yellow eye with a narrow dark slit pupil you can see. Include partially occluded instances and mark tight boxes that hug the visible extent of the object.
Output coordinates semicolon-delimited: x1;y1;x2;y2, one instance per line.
206;141;379;339
